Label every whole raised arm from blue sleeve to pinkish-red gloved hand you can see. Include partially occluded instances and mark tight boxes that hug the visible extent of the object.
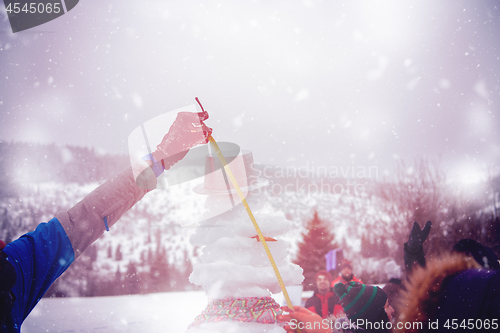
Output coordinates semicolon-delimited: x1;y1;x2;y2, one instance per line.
0;107;212;333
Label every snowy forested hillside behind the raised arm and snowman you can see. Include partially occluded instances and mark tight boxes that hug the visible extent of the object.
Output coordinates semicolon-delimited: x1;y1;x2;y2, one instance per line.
0;142;500;297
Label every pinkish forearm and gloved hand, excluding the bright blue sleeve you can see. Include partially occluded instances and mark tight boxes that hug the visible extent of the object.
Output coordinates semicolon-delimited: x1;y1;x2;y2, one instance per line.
56;111;212;258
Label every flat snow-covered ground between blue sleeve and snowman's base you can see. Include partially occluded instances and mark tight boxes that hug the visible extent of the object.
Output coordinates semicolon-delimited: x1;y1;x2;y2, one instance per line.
21;291;207;333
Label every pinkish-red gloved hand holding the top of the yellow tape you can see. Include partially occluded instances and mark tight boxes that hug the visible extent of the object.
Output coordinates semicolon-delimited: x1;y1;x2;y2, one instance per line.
152;111;212;170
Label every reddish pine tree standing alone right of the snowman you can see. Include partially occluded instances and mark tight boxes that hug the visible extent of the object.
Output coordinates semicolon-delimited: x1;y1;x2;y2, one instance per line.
295;211;335;290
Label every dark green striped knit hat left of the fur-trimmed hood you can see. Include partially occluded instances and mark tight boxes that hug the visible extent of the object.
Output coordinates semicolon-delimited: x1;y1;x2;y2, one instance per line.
333;281;387;322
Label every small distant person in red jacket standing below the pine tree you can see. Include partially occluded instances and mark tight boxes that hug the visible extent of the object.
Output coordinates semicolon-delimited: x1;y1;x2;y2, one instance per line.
305;270;344;318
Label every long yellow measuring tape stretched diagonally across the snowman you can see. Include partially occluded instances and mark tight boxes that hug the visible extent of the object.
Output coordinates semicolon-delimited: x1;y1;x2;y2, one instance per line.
208;135;293;311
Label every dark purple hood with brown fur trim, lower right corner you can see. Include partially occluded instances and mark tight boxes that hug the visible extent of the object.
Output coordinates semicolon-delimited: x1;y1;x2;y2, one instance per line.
394;254;500;332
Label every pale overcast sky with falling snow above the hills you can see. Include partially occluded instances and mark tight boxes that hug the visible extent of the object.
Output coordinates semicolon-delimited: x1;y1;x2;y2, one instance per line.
0;0;500;182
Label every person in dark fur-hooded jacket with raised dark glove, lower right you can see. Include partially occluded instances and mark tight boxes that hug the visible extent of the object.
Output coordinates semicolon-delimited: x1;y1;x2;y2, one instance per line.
395;222;500;332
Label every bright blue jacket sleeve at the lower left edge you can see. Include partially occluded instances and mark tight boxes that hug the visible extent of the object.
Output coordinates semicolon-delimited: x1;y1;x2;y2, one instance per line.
2;218;75;332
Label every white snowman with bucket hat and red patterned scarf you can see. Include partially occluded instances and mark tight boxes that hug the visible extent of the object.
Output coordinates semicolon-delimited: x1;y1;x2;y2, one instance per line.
187;151;304;333
